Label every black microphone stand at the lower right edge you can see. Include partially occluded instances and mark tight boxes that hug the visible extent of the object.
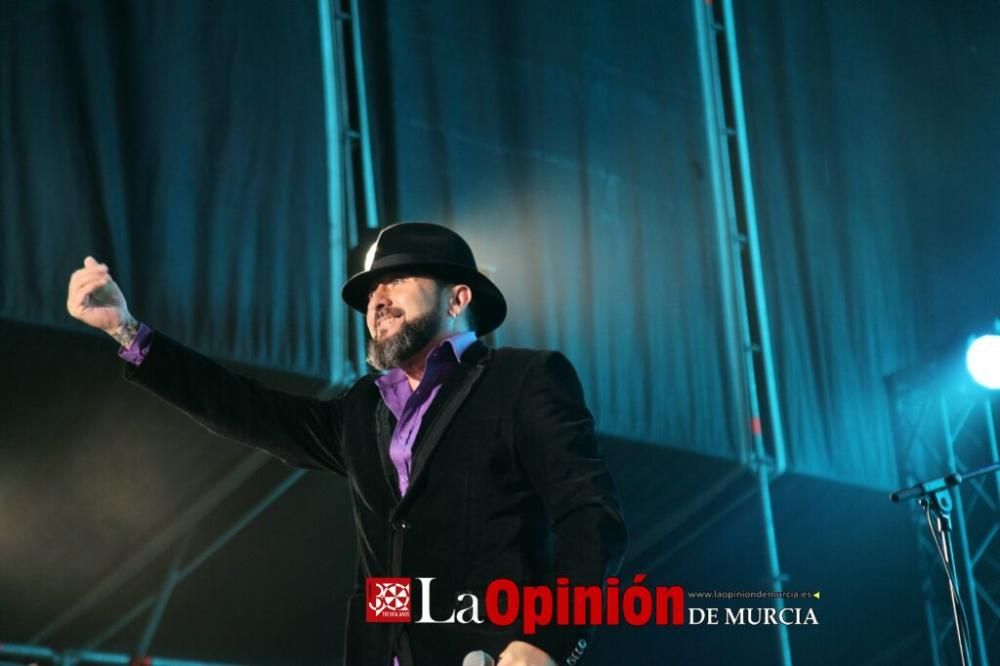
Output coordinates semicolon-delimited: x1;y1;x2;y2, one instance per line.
889;463;1000;666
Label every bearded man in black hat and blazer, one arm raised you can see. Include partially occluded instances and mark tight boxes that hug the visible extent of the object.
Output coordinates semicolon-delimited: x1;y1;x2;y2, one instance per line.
67;223;626;666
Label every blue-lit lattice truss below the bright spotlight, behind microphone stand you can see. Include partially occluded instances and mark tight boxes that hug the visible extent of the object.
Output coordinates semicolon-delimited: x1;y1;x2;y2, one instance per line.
889;359;1000;666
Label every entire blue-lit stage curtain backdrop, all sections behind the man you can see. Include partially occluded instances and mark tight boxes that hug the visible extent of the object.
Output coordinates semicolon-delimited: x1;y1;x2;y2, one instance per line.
0;0;1000;488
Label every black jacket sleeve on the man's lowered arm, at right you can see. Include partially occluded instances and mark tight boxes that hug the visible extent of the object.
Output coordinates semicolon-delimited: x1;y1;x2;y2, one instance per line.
516;352;628;666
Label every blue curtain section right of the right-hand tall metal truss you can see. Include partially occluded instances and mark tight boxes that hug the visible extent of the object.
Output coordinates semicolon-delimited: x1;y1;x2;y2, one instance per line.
736;0;1000;489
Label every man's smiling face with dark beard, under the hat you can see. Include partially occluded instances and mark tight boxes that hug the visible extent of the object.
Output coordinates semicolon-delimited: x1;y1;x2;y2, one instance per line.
365;273;446;370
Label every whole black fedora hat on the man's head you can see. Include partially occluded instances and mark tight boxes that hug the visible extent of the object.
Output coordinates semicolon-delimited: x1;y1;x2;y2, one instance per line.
341;222;507;335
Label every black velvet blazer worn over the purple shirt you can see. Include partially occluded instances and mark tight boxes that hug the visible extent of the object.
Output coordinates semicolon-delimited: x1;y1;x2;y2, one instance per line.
125;333;626;666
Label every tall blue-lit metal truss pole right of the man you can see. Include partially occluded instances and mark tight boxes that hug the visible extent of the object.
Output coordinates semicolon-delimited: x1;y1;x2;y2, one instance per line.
692;0;792;666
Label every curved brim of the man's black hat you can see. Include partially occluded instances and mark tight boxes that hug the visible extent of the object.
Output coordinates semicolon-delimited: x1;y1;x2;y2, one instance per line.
341;257;507;336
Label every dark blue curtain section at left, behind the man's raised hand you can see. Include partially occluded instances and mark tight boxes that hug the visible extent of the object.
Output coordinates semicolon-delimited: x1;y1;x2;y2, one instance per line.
0;0;339;379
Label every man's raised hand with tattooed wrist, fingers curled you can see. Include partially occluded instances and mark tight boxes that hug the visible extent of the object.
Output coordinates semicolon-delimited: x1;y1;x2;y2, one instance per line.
66;257;139;347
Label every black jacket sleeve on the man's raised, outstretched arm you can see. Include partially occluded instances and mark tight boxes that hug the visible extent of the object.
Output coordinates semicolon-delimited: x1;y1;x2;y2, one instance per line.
125;332;346;474
